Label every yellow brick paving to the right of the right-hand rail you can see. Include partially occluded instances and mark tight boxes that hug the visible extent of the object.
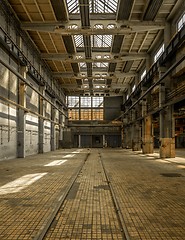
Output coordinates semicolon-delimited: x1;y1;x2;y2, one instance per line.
101;150;185;240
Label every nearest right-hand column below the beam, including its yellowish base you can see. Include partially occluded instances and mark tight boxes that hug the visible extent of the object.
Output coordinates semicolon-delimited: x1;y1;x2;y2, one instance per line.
159;106;175;158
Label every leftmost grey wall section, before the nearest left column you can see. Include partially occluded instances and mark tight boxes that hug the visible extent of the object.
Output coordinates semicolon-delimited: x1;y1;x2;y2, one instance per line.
0;57;17;160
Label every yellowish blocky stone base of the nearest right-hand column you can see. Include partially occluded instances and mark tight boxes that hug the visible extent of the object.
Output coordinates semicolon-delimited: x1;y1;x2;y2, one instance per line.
160;138;175;158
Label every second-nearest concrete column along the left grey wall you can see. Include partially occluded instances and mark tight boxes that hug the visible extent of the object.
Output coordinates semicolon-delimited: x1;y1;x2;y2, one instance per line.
38;86;45;153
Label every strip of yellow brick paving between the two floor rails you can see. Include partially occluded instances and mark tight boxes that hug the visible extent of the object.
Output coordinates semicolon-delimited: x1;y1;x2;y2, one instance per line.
45;150;123;240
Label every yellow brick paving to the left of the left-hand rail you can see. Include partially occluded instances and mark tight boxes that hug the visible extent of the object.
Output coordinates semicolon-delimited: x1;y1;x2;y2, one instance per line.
0;150;86;240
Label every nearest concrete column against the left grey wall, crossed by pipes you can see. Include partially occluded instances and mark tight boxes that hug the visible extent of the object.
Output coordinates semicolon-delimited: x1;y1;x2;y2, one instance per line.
17;67;27;158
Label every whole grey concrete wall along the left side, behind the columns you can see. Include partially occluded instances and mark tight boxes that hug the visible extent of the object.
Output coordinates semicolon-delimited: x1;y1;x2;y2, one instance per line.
0;2;65;160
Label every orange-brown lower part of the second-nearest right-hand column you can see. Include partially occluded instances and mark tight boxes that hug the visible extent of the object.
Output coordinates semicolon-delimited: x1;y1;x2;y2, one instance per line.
142;115;154;153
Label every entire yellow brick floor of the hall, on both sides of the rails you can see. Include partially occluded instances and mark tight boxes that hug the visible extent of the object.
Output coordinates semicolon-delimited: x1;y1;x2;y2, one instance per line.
0;149;185;240
